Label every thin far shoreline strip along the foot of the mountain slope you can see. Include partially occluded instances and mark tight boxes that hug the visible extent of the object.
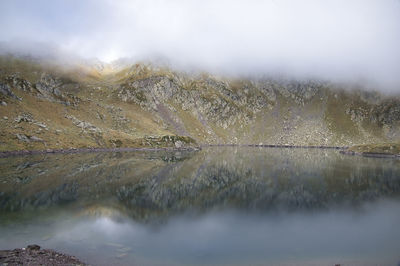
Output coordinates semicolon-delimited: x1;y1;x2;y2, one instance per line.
0;144;348;158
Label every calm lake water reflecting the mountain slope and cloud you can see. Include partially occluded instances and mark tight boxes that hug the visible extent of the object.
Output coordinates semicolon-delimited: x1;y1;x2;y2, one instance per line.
0;147;400;265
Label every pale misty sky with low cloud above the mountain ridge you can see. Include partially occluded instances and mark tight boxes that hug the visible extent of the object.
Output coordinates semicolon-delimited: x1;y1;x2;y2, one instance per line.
0;0;400;91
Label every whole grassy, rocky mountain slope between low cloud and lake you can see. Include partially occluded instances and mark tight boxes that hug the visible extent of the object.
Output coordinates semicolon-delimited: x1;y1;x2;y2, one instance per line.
0;55;400;151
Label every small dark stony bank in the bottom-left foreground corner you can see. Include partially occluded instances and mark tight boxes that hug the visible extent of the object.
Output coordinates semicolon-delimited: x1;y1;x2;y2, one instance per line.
0;245;87;266
